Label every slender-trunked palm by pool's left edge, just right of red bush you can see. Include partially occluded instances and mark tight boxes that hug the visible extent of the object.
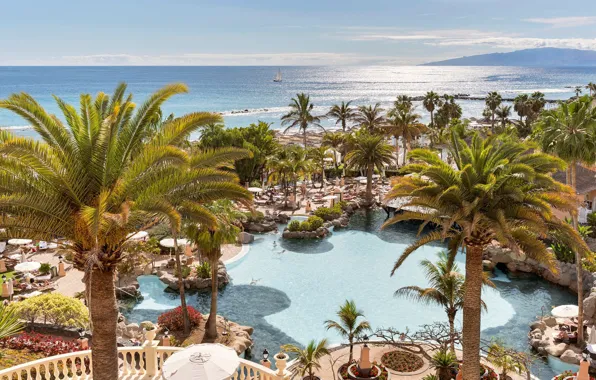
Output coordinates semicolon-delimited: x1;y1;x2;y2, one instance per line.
186;213;240;339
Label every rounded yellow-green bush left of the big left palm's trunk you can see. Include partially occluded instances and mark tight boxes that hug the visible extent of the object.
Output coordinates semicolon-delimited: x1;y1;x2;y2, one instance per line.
10;293;89;327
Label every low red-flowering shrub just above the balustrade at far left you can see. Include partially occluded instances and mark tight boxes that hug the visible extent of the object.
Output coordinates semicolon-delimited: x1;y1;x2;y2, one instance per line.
0;333;81;356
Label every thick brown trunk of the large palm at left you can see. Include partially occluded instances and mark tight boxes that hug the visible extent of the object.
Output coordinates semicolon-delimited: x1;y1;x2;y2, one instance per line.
87;269;118;380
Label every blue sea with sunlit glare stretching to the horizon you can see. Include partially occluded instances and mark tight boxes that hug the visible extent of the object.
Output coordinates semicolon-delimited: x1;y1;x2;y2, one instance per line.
0;66;596;139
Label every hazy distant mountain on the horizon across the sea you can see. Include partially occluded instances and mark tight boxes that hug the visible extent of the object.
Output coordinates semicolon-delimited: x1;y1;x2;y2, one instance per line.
422;48;596;67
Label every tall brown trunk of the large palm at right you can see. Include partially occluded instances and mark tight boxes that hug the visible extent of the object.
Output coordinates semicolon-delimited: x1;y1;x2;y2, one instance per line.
462;244;483;380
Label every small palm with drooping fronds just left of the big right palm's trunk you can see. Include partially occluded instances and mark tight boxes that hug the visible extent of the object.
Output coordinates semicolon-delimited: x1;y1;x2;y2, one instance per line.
395;252;494;353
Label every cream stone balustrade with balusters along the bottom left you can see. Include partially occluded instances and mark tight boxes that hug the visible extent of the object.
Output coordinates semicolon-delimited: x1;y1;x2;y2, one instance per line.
0;340;289;380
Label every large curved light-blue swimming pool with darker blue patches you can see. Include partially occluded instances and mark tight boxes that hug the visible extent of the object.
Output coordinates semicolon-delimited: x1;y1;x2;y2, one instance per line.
125;211;576;379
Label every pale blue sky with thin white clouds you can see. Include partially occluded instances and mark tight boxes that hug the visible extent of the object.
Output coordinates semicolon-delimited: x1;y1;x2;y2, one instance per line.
0;0;596;66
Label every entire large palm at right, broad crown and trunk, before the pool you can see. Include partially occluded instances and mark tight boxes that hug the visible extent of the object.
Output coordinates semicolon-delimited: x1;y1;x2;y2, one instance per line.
384;134;589;379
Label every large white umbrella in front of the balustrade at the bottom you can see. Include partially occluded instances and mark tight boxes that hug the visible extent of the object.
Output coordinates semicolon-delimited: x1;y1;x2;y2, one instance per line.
161;344;240;380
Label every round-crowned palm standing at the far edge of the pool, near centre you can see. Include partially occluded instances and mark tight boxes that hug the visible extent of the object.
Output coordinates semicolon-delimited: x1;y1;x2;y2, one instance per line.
346;132;393;205
